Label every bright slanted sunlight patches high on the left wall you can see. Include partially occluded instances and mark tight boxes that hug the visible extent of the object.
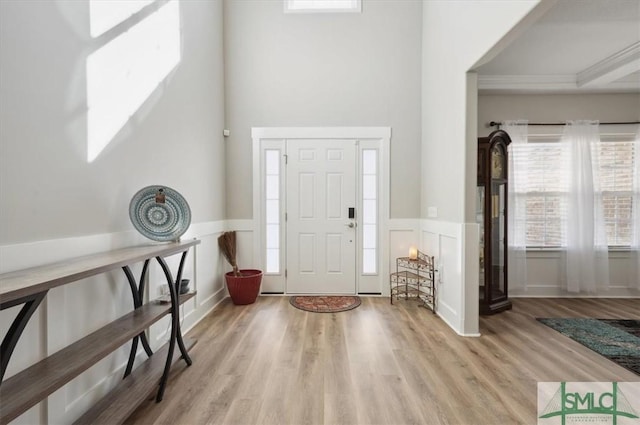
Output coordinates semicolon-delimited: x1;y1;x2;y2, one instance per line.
87;0;181;162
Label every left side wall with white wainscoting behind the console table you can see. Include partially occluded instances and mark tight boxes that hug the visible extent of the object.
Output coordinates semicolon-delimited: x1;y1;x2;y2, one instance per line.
0;0;227;424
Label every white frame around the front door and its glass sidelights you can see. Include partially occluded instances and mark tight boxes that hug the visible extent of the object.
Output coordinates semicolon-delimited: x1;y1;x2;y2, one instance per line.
251;127;391;294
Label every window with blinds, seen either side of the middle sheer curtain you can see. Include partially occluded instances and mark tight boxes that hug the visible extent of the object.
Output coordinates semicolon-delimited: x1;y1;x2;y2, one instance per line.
511;137;639;248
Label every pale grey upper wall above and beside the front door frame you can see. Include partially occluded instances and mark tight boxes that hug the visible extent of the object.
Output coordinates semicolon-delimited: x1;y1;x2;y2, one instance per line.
225;0;423;219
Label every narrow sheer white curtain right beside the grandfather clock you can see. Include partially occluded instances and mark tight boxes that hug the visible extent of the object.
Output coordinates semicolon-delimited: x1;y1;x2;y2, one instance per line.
502;120;528;290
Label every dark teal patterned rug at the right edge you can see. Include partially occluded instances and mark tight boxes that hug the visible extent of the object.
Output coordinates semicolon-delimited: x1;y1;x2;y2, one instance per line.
538;318;640;375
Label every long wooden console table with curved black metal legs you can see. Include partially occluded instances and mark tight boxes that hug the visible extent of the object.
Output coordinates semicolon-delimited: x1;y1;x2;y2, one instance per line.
0;239;200;424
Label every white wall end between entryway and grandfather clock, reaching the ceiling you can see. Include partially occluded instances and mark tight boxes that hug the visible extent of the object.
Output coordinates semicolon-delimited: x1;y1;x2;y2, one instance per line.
421;0;539;334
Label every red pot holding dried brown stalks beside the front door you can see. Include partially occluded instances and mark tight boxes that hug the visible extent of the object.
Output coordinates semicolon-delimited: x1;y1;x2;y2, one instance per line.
218;231;262;305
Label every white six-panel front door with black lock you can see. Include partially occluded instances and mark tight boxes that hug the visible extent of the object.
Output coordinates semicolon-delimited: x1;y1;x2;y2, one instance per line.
286;139;357;294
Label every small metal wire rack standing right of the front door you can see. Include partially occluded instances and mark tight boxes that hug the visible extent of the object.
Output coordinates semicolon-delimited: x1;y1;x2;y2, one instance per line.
389;251;436;314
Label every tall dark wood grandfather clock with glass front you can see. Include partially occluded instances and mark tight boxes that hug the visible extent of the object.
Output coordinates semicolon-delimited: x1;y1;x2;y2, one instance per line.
476;130;511;315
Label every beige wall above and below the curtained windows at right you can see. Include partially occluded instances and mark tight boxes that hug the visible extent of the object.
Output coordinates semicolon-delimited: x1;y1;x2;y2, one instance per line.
478;93;640;296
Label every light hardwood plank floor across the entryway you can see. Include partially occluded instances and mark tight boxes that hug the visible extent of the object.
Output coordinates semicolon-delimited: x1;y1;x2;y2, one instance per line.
122;297;640;425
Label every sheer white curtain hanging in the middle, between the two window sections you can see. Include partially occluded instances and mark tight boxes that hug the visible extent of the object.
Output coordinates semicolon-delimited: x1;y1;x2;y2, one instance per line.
562;121;609;293
